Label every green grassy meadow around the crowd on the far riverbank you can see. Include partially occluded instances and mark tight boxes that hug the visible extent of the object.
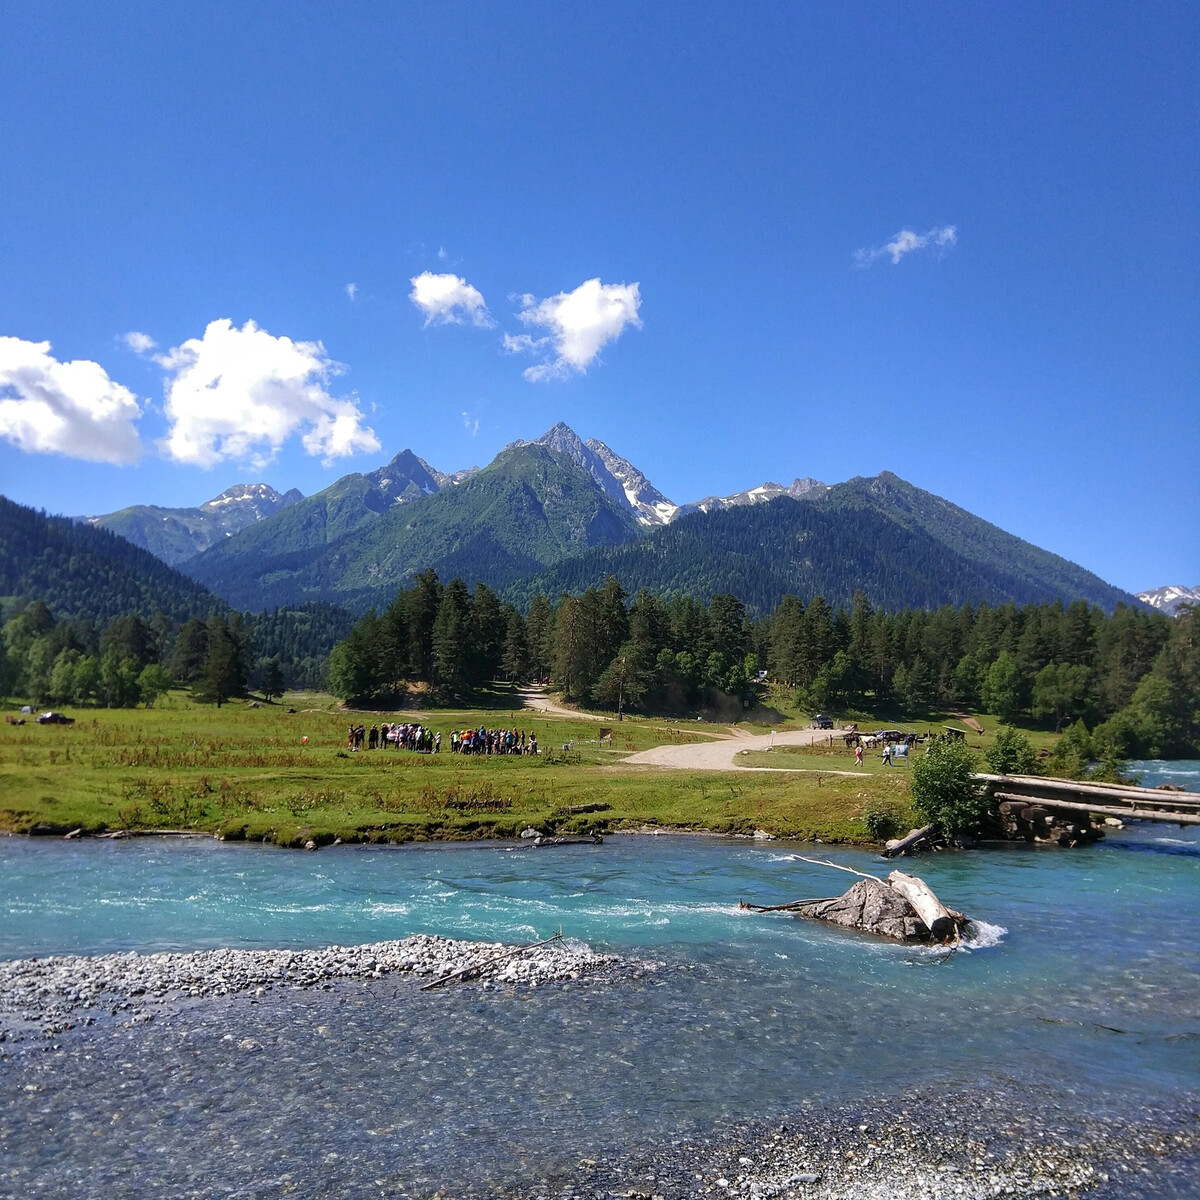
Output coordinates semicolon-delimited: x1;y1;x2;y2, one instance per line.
0;692;926;846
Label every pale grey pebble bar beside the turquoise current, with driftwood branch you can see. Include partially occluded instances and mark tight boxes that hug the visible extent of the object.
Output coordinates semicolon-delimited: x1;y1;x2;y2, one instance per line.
0;934;646;1042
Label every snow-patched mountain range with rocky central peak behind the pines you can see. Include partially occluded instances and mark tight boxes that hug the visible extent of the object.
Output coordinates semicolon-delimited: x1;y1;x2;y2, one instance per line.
63;424;1123;611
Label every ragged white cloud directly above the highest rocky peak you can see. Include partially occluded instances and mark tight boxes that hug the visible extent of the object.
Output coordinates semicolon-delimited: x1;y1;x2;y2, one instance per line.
504;278;642;383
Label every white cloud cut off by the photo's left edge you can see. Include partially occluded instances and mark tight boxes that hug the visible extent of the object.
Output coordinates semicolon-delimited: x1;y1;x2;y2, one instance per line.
0;337;142;463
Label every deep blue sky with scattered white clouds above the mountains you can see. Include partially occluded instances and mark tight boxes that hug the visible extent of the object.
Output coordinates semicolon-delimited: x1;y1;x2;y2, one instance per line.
0;0;1200;589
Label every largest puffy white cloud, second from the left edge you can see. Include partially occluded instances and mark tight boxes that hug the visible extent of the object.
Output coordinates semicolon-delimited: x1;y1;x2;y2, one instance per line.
157;319;380;467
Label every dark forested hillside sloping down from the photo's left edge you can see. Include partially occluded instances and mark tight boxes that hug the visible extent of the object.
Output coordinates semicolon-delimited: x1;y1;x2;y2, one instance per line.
0;497;224;624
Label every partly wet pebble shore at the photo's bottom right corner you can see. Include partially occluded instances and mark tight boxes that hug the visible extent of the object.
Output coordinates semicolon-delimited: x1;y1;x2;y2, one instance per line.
556;1088;1200;1200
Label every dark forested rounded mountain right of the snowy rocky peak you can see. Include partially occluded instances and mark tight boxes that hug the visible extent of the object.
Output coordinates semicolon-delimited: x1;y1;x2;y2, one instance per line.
516;476;1138;613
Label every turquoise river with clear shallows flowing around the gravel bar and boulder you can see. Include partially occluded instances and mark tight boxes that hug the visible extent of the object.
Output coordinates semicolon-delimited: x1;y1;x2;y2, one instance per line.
0;796;1200;1198
